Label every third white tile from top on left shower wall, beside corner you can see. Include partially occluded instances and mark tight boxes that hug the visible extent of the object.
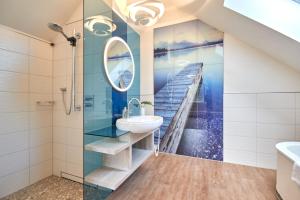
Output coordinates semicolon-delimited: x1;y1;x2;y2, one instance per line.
30;75;52;94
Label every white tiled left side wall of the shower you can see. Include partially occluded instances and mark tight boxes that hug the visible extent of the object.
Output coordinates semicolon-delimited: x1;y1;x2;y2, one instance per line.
0;26;52;198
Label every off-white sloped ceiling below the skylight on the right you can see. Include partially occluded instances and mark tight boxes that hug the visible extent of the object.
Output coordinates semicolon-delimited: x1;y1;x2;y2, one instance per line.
163;0;300;71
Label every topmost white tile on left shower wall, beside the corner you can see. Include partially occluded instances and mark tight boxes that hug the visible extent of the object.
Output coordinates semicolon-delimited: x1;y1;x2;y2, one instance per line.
29;39;53;60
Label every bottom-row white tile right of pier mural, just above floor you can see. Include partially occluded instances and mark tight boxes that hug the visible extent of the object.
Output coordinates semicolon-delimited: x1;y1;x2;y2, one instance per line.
224;149;256;166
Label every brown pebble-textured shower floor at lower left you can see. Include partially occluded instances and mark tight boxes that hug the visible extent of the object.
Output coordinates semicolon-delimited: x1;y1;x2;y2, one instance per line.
1;176;83;200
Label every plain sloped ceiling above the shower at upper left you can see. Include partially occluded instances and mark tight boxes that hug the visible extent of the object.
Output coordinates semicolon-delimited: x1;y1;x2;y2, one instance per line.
0;0;83;41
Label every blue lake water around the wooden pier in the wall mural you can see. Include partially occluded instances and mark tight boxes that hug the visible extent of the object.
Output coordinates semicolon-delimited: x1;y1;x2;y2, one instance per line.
154;44;224;160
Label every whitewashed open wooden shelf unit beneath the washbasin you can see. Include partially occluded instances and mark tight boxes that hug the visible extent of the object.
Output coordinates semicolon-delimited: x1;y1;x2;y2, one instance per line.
85;132;154;190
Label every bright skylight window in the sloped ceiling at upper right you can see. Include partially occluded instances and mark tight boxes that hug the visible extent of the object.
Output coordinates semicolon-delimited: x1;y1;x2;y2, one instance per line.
224;0;300;42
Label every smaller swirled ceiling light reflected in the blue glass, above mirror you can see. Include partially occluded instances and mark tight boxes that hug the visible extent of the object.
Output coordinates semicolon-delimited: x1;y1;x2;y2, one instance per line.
84;15;117;36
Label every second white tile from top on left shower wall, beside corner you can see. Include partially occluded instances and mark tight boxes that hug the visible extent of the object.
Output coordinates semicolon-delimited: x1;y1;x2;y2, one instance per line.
29;57;52;77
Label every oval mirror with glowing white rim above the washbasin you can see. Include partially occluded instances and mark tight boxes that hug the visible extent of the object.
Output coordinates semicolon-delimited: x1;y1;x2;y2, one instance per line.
104;37;135;92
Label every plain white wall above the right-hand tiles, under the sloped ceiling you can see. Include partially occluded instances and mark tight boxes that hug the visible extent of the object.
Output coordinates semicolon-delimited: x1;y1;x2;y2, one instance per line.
224;33;300;93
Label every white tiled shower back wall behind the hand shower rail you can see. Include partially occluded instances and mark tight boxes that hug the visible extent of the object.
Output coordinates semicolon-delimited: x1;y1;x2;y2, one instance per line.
53;2;83;181
